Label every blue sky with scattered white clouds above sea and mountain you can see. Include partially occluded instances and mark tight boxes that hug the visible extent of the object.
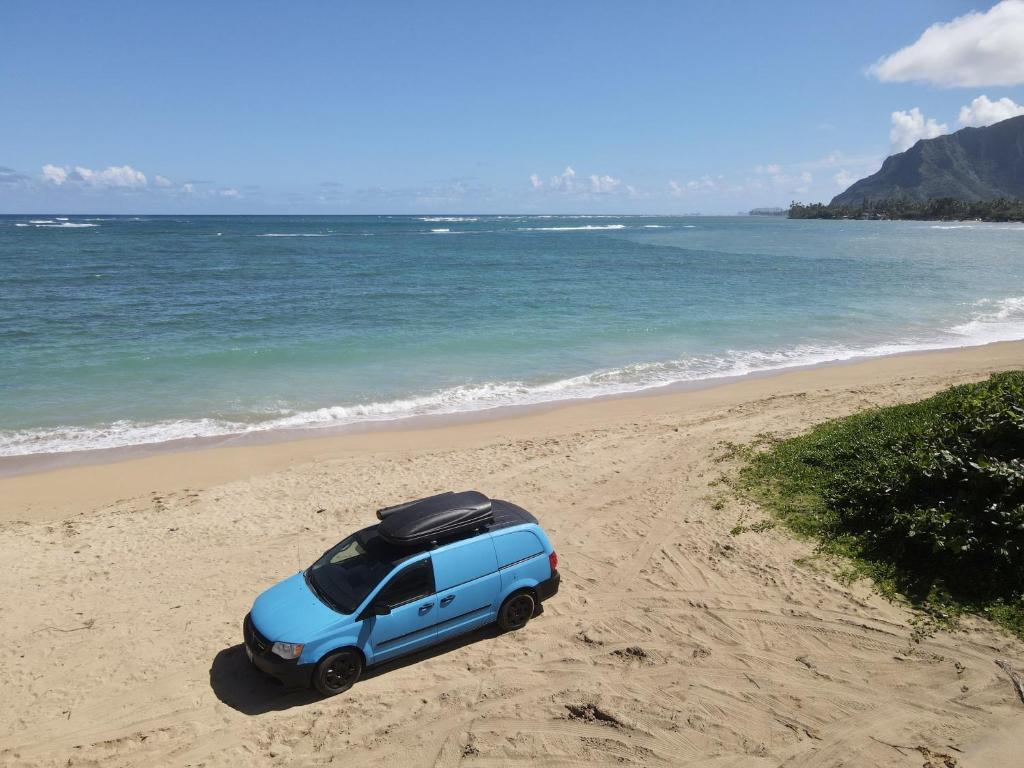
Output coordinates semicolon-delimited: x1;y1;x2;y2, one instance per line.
0;0;1024;213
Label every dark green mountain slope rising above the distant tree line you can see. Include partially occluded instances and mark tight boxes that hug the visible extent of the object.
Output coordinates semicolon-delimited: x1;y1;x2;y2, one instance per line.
831;115;1024;206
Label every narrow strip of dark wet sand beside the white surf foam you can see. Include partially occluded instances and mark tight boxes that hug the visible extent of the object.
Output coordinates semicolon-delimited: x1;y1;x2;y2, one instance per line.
0;339;1024;480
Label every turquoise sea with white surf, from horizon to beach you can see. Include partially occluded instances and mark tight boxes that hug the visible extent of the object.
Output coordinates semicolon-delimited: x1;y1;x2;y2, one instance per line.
0;216;1024;456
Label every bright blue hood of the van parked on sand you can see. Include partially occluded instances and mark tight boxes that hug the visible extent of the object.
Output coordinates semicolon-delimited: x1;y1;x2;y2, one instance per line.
251;571;352;643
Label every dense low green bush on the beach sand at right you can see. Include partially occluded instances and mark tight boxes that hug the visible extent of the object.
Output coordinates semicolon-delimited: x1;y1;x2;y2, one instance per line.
740;371;1024;637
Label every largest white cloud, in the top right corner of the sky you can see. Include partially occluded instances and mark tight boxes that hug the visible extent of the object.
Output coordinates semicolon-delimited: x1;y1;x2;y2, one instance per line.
868;0;1024;87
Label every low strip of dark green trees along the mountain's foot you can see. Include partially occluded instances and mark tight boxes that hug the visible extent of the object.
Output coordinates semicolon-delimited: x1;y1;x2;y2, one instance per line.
790;198;1024;221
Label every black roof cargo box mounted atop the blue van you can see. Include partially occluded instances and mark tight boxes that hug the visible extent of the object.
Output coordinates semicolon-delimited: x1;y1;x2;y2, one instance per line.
377;490;494;547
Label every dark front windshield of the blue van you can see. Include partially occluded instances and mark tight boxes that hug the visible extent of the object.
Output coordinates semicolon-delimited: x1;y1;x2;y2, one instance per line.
305;526;405;613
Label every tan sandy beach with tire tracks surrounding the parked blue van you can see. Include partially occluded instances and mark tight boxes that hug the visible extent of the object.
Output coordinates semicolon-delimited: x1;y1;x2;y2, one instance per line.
0;343;1024;766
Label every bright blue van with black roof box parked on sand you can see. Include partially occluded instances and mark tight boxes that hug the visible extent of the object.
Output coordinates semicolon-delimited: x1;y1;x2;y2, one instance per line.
243;490;560;695
